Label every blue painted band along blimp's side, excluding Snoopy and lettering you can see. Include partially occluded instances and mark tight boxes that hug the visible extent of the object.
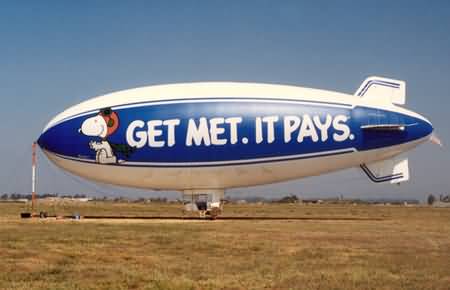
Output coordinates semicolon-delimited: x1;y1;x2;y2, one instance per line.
38;99;432;165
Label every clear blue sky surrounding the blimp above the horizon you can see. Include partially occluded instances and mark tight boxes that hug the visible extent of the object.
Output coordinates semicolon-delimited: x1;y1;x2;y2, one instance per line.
0;1;450;199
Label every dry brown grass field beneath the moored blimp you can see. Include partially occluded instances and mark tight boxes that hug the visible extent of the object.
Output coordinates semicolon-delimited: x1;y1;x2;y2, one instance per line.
0;203;450;289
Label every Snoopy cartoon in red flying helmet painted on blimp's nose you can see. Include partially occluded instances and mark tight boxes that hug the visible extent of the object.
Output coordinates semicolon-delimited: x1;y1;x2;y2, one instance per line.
78;108;134;164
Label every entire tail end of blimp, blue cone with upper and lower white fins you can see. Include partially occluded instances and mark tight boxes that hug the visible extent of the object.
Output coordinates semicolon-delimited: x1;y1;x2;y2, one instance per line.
353;77;433;183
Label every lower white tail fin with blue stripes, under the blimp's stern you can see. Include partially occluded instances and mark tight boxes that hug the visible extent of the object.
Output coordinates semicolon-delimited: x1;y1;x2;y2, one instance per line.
361;158;409;183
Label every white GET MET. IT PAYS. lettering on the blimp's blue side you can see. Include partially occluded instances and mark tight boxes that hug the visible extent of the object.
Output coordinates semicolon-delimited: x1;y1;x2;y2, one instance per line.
126;114;354;148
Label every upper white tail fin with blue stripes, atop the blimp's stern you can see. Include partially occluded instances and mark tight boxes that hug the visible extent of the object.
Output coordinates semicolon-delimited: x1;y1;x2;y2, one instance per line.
355;76;406;105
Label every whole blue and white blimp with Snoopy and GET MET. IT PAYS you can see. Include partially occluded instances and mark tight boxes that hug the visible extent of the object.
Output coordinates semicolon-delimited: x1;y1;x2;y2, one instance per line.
37;76;433;215
